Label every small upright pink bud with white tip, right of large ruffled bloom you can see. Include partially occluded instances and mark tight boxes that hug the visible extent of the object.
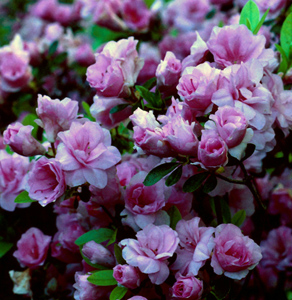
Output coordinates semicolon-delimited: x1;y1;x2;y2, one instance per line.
155;51;182;87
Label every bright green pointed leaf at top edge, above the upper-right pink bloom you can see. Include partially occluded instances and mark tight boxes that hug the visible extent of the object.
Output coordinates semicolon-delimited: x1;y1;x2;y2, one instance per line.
239;0;260;31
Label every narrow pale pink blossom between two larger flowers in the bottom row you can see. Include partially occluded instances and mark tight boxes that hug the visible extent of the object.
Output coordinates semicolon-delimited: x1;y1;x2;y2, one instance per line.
172;217;215;275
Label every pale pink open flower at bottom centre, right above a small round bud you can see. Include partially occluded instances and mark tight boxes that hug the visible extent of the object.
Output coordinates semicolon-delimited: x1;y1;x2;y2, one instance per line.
120;224;179;285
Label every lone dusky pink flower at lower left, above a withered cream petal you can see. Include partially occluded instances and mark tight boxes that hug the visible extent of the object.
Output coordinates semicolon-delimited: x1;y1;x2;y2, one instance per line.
13;227;51;268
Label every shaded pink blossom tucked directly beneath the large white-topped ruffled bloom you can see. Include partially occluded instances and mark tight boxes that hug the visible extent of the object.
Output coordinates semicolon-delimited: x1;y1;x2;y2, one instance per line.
90;96;132;129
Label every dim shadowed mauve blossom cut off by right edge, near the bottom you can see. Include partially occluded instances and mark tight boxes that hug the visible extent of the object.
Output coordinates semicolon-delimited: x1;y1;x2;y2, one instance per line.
260;226;292;271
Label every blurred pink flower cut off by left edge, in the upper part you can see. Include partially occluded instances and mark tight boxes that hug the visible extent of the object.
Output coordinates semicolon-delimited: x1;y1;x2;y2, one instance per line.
0;52;32;92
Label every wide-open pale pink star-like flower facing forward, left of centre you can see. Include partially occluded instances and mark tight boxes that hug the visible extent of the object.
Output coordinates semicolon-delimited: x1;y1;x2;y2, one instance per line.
56;121;121;189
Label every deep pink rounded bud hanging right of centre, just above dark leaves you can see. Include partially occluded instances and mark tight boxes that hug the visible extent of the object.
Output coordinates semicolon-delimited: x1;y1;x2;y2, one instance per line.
198;130;228;168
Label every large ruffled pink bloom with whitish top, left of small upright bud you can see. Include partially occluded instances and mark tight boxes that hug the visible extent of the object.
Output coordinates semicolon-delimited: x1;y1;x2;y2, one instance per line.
86;37;143;97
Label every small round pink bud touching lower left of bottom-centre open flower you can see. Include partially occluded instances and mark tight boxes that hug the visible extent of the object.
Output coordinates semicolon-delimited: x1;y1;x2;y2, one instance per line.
113;265;140;289
